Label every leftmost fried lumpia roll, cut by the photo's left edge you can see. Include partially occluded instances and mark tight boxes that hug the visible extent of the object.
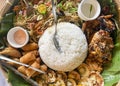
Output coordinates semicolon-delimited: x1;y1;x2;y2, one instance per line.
0;47;21;58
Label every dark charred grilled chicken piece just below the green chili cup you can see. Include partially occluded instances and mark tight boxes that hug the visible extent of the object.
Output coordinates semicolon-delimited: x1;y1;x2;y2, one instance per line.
82;15;116;43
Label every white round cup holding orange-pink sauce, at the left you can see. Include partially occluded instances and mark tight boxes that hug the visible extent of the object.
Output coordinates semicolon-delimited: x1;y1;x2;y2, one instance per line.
7;26;29;48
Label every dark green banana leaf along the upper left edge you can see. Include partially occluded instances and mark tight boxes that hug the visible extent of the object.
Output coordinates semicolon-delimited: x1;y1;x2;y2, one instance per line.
0;0;19;50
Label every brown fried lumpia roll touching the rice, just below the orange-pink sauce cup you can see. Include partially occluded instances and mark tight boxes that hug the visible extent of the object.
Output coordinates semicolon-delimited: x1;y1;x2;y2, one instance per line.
22;42;38;51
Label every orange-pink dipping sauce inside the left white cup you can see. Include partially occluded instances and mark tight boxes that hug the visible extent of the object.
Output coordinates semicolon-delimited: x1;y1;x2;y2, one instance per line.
14;30;26;45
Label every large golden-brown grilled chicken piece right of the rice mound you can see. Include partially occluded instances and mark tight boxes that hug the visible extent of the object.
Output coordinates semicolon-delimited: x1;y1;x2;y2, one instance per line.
88;30;114;63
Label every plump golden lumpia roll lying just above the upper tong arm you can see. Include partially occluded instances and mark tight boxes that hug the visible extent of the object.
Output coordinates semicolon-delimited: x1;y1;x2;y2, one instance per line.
20;52;36;64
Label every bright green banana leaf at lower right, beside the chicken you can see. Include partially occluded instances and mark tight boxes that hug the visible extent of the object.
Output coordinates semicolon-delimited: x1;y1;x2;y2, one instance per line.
102;31;120;86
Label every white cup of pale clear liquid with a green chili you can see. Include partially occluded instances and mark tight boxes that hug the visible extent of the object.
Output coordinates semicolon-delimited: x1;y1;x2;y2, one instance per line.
78;0;101;21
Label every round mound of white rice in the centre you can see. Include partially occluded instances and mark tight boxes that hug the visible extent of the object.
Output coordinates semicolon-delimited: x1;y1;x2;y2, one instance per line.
38;22;88;72
